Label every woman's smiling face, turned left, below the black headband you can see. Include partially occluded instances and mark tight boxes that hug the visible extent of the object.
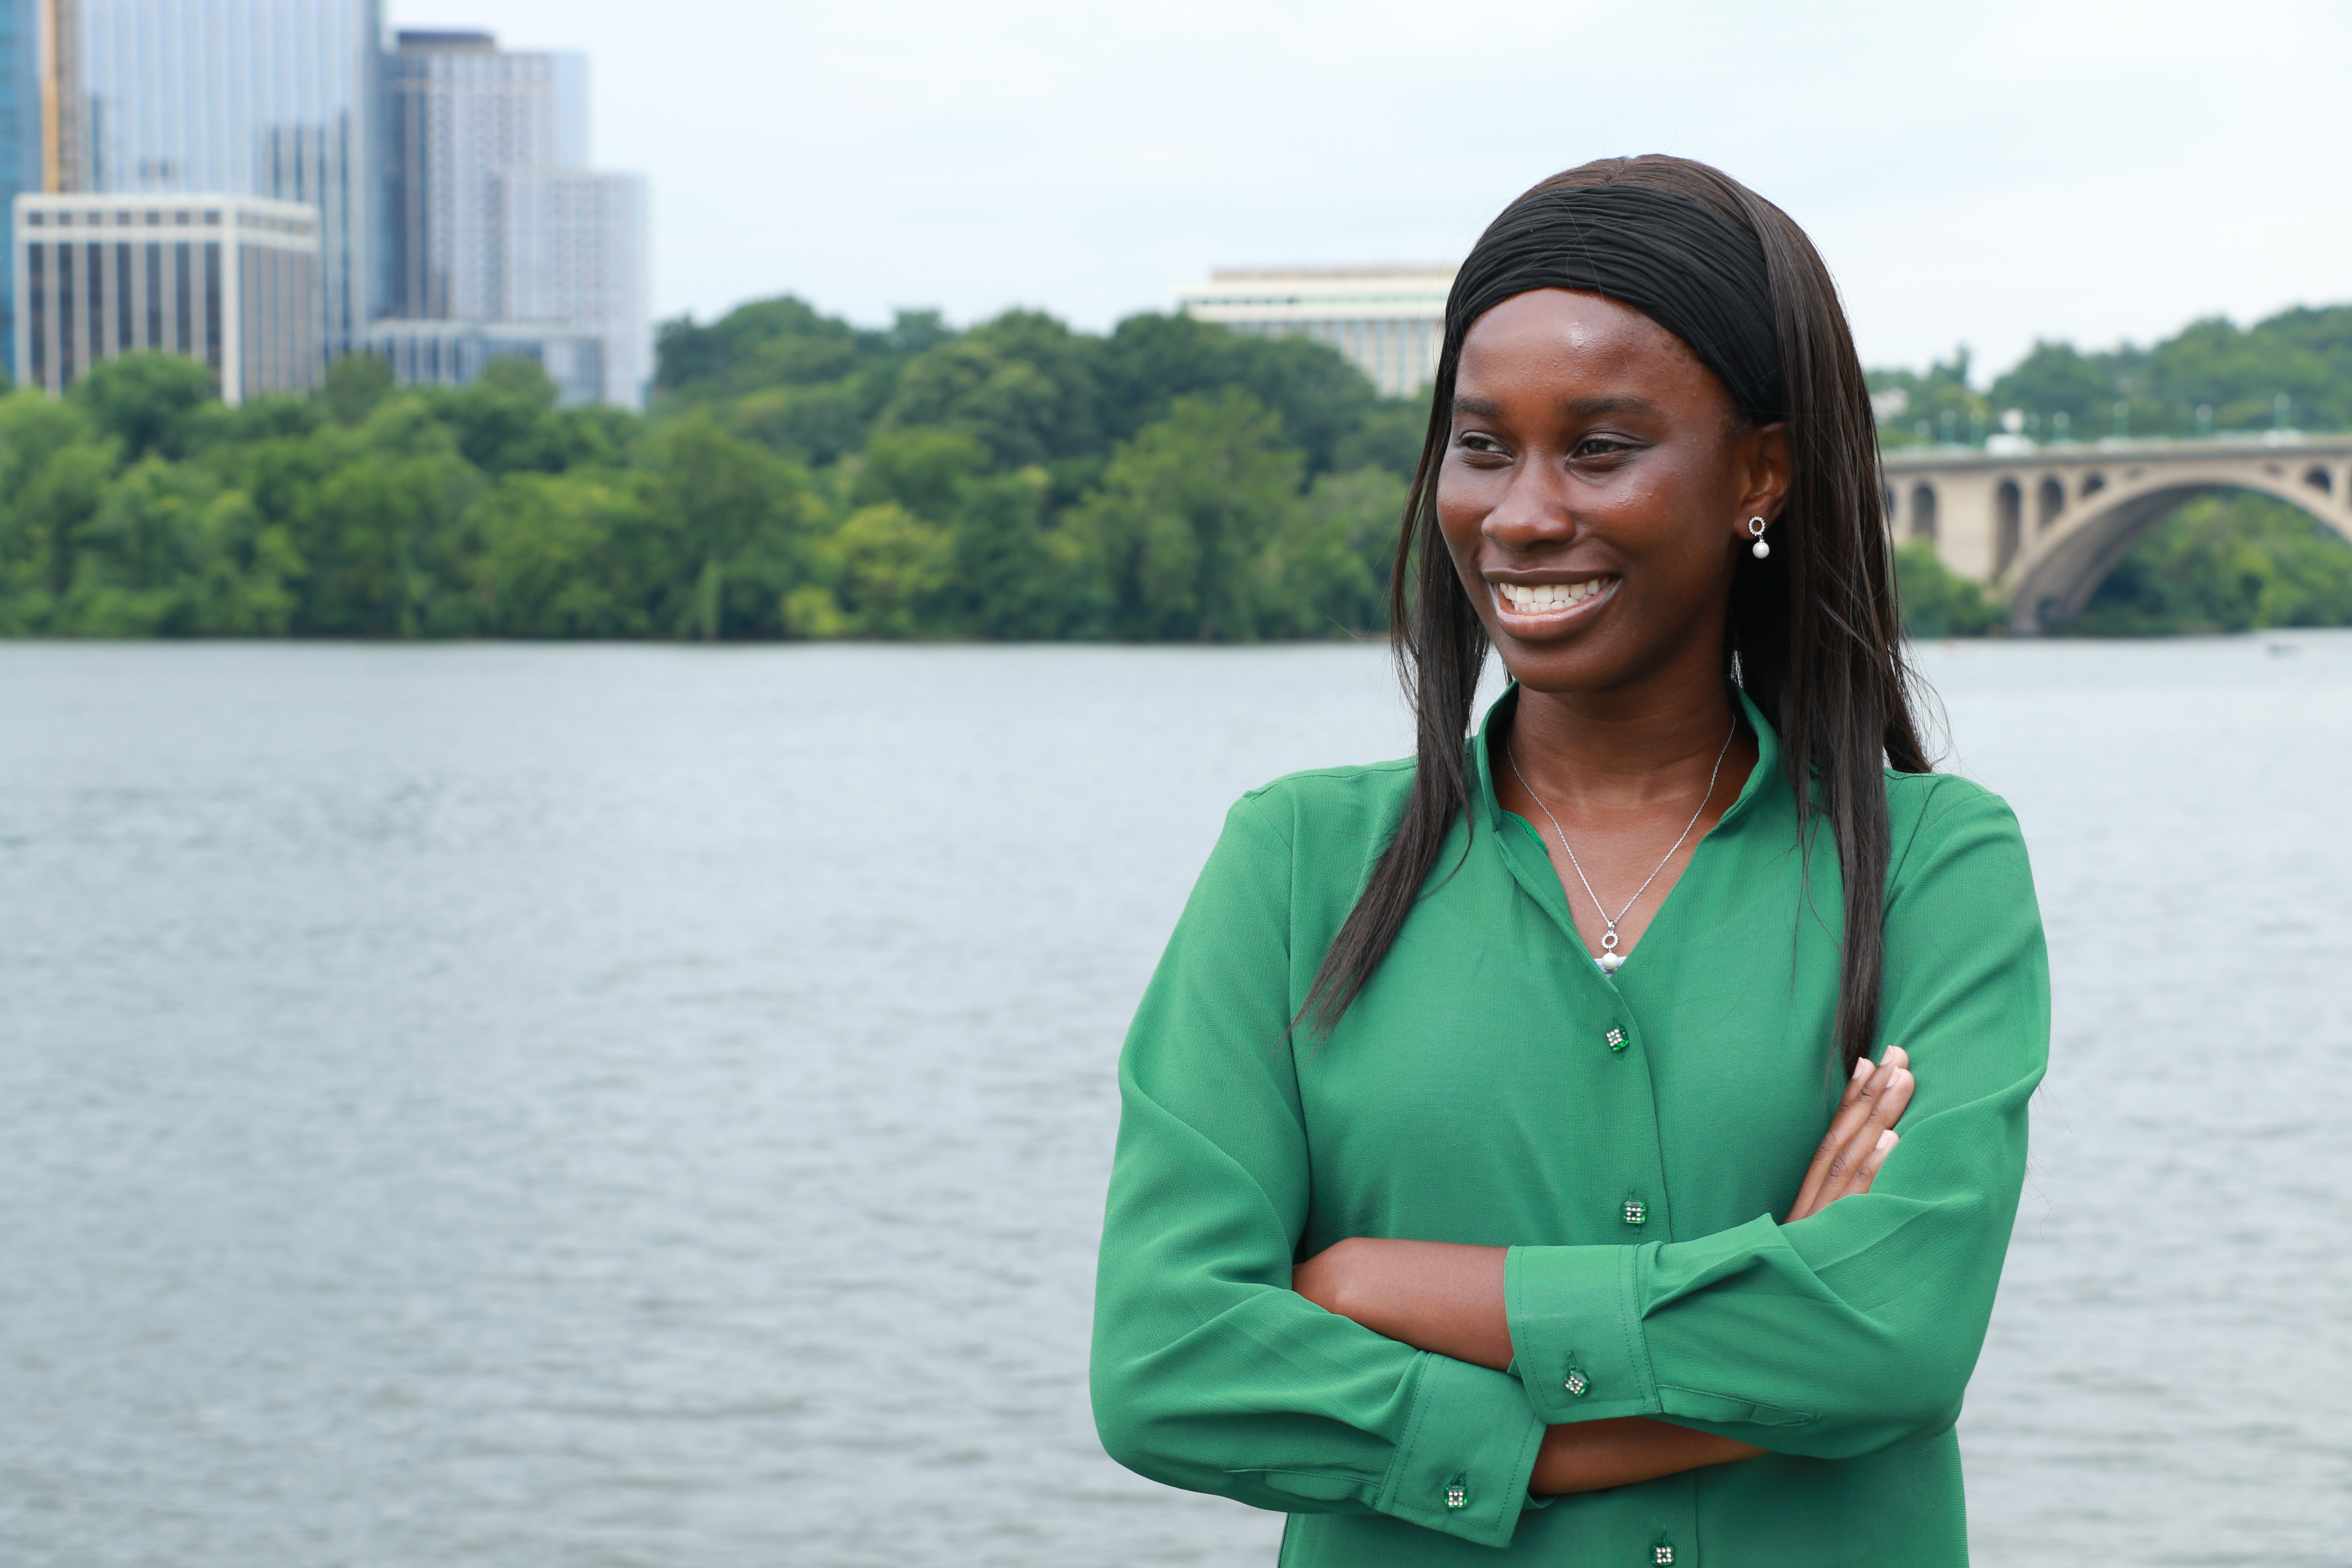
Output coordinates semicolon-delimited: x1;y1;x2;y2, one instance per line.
1437;289;1788;693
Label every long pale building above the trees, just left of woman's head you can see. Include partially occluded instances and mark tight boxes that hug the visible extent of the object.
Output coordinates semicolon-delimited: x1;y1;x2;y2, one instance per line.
1176;266;1456;397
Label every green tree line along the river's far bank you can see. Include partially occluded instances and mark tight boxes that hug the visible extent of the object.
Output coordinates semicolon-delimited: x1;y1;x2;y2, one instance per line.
0;299;2352;642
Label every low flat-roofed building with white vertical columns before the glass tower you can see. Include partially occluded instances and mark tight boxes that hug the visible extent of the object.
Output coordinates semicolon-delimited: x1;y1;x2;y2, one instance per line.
12;195;325;404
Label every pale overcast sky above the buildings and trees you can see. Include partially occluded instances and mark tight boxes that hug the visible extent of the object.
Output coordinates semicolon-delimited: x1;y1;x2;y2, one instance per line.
390;0;2352;381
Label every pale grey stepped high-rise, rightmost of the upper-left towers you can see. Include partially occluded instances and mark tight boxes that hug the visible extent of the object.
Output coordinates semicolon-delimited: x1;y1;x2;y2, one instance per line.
374;33;647;404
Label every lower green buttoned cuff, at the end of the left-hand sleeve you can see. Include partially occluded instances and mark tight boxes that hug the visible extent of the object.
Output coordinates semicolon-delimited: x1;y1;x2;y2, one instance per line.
1374;1352;1543;1547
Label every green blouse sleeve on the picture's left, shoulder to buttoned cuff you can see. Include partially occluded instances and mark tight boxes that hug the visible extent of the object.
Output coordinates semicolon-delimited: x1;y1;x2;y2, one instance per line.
1091;797;1543;1547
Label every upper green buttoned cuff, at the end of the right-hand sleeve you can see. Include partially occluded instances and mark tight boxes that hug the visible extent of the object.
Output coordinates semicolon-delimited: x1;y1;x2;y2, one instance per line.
1503;1246;1658;1427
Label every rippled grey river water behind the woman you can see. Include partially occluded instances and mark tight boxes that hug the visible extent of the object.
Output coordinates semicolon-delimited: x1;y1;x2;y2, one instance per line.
0;635;2352;1568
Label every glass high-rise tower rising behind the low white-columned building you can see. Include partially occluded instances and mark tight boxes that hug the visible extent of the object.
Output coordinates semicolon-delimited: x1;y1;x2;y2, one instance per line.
45;0;386;355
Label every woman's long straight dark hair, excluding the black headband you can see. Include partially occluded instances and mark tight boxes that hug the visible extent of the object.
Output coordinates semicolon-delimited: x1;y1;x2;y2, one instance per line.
1301;155;1931;1072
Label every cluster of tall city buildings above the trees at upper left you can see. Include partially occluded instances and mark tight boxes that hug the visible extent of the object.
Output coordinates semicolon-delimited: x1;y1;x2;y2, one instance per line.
0;0;652;407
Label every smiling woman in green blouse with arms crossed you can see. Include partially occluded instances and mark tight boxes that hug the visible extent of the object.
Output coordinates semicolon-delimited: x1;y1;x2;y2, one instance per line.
1093;157;2049;1568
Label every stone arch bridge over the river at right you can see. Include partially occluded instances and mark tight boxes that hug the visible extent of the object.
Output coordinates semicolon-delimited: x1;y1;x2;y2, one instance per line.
1884;435;2352;632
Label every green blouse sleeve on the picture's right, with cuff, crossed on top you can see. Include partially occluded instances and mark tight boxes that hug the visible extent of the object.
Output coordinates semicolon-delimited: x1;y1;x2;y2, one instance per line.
1505;778;2049;1458
